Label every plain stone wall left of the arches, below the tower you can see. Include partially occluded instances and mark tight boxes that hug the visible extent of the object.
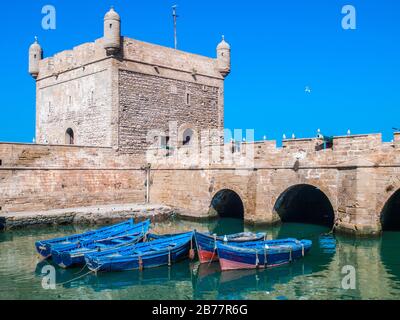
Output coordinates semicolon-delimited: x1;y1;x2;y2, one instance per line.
0;144;146;212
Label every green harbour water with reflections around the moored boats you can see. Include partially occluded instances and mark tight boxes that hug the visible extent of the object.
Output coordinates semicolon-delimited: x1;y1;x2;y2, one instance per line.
0;219;400;300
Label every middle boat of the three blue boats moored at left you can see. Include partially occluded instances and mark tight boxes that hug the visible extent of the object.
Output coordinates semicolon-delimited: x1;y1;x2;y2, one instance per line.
51;220;151;268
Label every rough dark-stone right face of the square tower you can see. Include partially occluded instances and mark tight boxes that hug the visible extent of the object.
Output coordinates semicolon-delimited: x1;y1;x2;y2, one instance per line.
119;70;223;154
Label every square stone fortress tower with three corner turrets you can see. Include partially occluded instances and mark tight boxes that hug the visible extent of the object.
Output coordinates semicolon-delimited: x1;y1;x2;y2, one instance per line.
29;8;231;154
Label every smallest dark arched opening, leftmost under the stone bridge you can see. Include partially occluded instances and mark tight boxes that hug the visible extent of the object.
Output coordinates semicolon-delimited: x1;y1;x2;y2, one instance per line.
210;189;244;220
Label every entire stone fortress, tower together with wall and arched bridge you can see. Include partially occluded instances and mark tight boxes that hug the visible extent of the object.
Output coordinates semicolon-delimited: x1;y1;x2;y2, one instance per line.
0;10;400;235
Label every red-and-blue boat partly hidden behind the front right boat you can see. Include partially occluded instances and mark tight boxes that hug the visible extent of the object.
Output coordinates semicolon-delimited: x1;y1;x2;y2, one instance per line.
194;231;267;264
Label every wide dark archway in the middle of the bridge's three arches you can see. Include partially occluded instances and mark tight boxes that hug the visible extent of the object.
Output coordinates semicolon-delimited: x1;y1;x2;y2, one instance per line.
274;184;335;227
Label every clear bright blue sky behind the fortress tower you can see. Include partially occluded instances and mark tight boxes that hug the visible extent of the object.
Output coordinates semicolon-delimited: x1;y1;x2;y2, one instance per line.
0;0;400;142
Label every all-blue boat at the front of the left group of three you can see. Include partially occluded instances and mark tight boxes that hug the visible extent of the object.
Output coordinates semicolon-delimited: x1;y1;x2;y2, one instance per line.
85;232;193;272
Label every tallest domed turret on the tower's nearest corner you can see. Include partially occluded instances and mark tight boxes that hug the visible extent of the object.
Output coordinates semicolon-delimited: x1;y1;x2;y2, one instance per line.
104;8;121;55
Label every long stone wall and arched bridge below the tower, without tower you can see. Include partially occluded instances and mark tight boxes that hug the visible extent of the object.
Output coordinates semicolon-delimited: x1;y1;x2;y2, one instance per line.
0;135;400;235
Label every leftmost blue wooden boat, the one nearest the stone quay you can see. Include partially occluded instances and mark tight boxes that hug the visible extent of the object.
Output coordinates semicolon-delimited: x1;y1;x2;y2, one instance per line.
35;219;135;259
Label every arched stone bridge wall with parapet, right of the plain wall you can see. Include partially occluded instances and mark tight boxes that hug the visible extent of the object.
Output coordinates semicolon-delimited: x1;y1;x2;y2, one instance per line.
151;135;400;235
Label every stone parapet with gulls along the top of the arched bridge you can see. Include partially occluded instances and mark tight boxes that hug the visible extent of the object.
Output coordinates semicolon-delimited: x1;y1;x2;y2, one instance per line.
148;133;400;168
